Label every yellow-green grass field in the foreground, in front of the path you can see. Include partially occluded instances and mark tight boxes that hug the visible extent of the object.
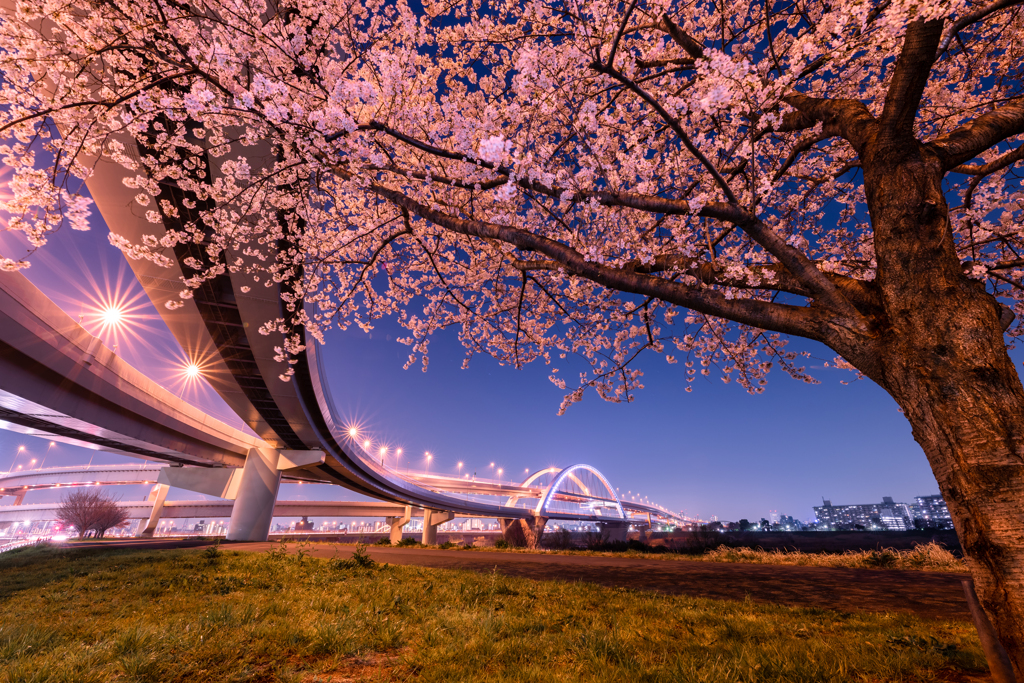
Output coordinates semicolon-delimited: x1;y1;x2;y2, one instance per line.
0;548;984;683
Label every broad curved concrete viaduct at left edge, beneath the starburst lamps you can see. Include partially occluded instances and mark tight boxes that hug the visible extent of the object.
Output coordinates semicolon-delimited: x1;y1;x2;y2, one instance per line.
0;272;266;467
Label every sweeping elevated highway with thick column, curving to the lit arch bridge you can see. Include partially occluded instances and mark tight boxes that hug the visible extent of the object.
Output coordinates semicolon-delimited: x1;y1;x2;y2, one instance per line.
0;140;679;540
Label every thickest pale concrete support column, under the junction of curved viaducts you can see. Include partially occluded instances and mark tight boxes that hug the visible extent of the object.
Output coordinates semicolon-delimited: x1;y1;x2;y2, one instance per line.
227;449;281;541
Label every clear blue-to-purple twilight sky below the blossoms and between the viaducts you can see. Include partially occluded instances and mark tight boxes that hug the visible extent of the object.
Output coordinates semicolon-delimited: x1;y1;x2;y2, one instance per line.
0;217;937;519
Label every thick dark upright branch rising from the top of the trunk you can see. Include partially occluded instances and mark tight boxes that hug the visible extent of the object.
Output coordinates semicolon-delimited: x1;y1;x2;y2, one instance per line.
879;19;942;138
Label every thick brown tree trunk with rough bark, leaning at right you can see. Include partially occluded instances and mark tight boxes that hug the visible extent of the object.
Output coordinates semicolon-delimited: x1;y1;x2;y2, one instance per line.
851;140;1024;681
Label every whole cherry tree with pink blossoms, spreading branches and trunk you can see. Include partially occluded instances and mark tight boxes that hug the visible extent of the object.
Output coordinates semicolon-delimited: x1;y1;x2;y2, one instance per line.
0;0;1024;678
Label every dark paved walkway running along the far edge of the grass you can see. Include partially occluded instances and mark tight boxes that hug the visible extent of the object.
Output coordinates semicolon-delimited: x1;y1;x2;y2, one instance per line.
68;539;971;621
